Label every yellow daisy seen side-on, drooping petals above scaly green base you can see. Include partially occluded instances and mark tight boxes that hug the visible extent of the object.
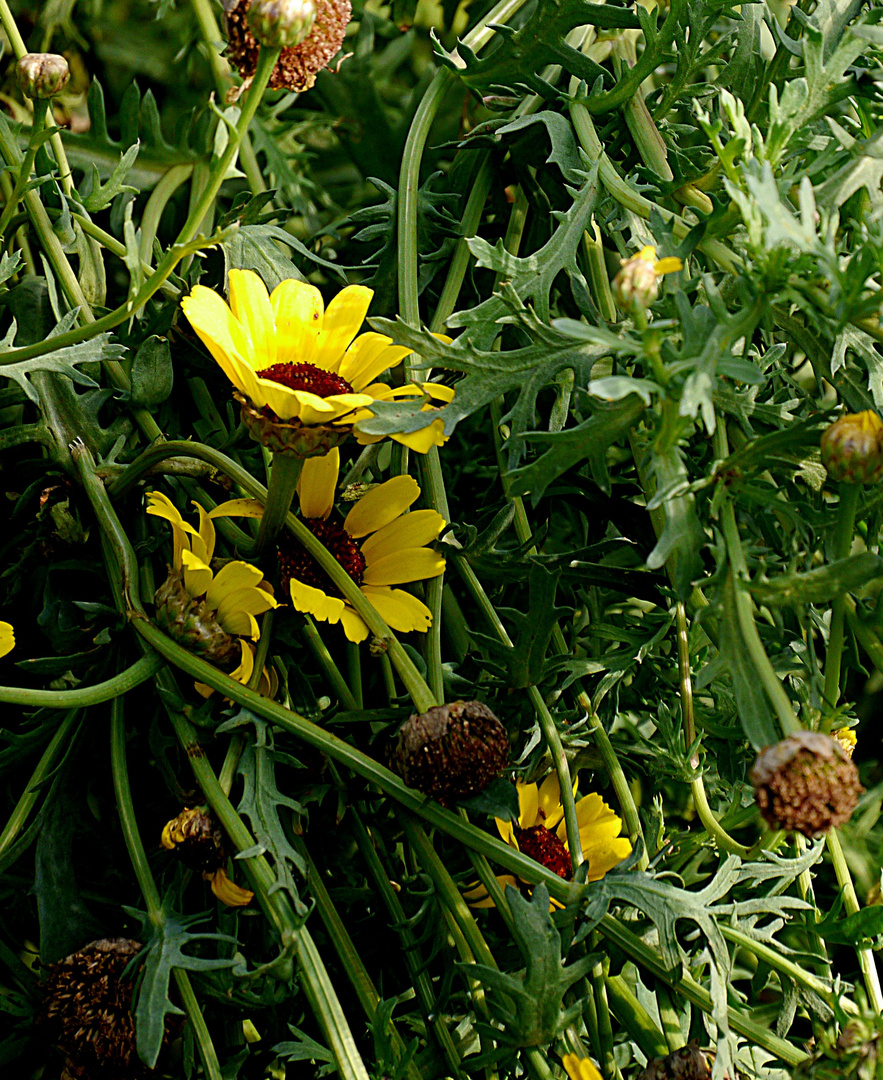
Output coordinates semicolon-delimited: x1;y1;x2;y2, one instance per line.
147;491;279;683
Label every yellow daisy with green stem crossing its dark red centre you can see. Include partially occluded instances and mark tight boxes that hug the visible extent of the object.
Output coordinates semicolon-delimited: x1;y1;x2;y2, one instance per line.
279;450;445;642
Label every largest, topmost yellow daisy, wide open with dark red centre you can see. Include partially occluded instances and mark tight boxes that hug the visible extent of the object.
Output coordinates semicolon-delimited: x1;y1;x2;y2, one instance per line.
181;270;444;457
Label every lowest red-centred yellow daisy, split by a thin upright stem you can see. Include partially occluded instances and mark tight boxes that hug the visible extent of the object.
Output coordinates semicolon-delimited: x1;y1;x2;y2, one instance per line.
465;772;631;907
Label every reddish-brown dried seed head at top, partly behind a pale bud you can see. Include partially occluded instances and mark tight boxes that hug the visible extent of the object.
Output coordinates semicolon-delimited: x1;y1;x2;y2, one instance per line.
225;0;353;92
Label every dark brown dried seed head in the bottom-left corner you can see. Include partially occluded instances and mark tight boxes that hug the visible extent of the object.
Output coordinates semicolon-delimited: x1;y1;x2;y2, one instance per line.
39;937;168;1080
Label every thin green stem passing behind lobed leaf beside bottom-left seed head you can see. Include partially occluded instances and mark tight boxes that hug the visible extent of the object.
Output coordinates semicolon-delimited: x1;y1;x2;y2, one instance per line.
110;697;222;1080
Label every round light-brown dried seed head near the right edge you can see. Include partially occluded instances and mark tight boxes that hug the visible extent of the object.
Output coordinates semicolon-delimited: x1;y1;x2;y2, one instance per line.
749;731;864;837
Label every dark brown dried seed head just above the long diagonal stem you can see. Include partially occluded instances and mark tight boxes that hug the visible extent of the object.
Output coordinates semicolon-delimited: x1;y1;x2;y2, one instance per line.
392;701;508;802
